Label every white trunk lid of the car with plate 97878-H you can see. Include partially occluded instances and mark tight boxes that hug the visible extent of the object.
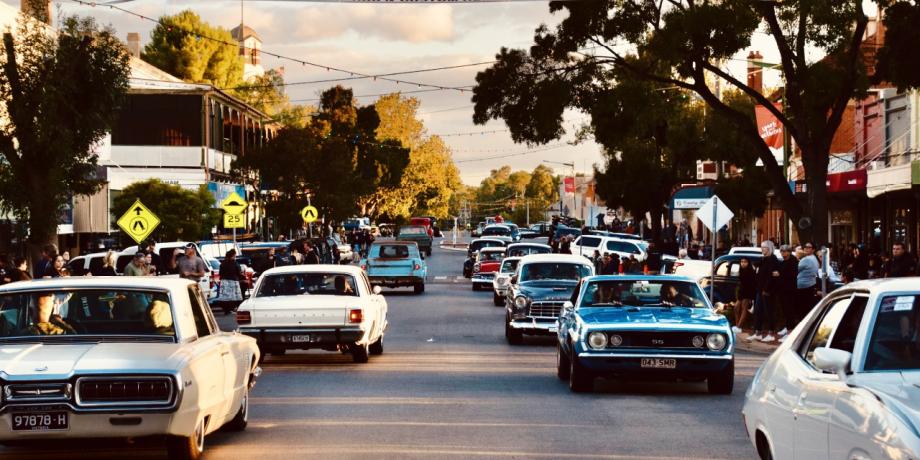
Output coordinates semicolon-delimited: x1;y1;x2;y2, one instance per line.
0;342;185;381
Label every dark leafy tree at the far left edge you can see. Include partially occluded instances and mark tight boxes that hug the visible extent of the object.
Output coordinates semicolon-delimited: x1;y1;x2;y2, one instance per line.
0;17;130;266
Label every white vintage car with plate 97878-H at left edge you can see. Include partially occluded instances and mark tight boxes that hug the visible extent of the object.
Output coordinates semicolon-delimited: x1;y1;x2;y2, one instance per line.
0;277;261;459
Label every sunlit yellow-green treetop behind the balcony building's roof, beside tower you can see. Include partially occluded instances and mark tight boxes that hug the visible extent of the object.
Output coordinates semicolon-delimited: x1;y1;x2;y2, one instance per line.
143;10;243;88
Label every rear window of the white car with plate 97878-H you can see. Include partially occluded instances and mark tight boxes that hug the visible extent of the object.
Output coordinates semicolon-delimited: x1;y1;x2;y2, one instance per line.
0;289;176;338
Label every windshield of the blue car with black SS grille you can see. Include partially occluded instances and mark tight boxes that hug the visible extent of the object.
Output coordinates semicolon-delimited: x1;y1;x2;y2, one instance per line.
579;280;708;308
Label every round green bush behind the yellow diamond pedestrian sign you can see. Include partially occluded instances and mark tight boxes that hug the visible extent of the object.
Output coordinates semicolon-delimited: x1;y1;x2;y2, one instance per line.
112;179;222;241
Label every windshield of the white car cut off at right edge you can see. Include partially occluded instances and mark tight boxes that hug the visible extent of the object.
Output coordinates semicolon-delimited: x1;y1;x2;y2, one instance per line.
866;294;920;371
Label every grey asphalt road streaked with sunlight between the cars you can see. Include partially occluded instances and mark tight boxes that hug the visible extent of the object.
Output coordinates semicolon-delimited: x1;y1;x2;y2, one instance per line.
0;239;764;460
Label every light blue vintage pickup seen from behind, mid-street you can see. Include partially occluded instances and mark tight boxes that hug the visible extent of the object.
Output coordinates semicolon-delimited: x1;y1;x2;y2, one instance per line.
361;241;428;294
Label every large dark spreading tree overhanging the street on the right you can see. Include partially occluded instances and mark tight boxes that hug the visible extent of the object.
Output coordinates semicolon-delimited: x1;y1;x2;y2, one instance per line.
473;0;920;244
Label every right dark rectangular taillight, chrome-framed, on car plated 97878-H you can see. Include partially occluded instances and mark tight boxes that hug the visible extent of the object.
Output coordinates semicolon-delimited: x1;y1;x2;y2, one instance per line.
77;376;175;406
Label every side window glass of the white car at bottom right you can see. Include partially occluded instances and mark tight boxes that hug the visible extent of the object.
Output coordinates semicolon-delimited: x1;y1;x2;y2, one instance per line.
800;296;867;367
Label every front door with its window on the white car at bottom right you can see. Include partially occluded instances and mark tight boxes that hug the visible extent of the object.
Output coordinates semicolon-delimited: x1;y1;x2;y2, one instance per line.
792;295;868;459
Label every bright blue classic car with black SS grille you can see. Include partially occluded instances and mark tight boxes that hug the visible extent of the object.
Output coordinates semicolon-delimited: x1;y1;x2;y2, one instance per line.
556;275;735;394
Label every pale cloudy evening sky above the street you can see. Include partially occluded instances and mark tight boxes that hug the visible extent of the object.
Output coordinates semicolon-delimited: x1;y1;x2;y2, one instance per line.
3;0;812;185
